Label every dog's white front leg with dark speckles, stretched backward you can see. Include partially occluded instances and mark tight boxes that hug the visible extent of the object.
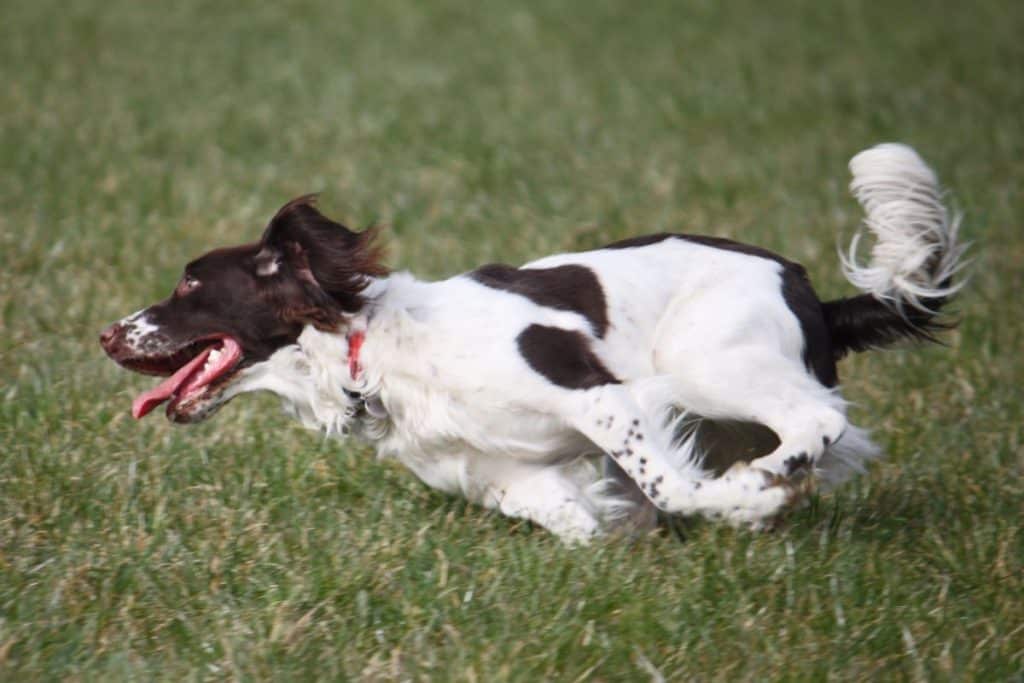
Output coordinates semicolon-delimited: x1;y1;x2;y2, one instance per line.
565;384;796;527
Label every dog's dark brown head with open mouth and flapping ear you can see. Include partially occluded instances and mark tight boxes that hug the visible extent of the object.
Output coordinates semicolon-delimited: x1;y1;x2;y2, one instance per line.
99;196;385;422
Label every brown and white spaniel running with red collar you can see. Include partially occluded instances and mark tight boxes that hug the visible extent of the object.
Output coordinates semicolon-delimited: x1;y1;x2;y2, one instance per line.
100;143;965;543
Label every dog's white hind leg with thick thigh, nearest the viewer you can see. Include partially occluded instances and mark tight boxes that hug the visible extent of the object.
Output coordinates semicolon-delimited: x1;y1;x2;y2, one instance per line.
654;281;847;476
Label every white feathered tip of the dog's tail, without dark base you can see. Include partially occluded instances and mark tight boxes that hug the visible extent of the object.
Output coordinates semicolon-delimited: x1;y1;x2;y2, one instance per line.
840;143;967;313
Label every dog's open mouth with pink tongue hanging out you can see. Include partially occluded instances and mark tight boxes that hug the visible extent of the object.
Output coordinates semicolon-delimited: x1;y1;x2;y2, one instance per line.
130;336;242;420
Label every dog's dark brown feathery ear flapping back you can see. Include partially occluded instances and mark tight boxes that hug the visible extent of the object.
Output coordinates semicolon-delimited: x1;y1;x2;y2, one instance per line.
256;195;387;312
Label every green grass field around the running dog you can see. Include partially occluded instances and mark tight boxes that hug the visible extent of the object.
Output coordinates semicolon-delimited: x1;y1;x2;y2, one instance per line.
0;0;1024;682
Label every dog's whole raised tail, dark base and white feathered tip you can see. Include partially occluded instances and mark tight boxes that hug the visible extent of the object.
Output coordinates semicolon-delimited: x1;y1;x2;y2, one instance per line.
822;143;967;359
